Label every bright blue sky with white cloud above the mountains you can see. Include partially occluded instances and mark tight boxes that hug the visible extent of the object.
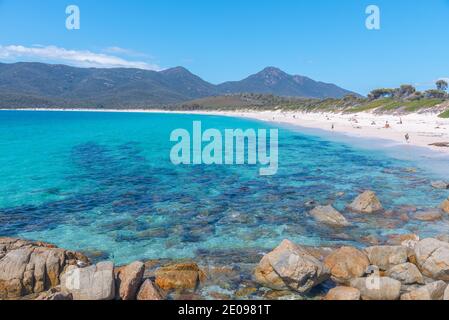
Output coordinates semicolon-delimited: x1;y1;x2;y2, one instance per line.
0;0;449;94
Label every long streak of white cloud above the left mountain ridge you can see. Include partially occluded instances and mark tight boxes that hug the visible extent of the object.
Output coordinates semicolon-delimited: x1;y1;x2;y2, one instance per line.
0;45;161;71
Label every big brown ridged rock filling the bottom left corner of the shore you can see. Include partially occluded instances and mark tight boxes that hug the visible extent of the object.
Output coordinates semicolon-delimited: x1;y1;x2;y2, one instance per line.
0;238;89;299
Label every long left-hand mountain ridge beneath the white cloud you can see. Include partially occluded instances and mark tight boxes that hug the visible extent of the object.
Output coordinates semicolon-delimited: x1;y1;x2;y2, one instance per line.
0;63;216;107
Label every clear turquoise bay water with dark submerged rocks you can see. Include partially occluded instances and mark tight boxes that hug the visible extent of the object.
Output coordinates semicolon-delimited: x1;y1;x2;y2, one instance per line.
0;111;449;264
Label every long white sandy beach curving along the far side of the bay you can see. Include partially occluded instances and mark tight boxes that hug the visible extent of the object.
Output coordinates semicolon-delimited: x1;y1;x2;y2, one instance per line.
0;108;449;155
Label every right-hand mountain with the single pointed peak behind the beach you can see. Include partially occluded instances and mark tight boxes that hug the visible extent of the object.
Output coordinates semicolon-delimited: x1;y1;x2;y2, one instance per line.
218;67;355;98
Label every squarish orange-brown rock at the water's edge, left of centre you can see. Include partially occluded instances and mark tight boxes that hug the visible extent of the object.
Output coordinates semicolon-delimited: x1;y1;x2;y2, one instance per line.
155;263;206;291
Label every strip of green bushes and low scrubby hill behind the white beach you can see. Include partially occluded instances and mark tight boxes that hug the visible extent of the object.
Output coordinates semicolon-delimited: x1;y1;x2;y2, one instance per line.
177;80;449;117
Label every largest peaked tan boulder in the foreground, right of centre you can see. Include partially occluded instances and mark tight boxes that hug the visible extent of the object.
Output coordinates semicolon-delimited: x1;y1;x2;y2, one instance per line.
255;240;330;293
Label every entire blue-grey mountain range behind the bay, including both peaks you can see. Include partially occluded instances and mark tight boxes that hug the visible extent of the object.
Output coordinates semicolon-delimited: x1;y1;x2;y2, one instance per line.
0;62;351;108
